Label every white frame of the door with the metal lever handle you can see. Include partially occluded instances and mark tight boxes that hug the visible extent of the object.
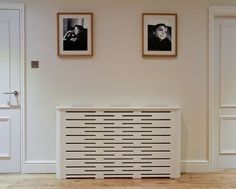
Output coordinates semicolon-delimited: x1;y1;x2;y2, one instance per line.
0;3;26;173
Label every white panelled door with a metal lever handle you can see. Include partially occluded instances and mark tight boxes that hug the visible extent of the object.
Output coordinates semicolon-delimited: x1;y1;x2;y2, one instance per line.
0;6;21;173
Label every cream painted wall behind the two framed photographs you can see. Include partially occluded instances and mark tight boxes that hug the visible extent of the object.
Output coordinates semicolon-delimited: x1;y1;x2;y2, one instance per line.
0;0;236;171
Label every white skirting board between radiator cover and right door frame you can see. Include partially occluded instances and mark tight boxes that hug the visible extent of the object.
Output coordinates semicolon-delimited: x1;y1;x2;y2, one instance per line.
181;160;211;173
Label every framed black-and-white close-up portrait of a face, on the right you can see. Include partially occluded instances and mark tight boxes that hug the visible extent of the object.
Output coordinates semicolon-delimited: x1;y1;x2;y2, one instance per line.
142;13;177;57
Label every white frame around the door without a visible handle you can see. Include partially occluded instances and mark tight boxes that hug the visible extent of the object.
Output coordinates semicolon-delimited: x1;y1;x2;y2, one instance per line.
208;6;236;171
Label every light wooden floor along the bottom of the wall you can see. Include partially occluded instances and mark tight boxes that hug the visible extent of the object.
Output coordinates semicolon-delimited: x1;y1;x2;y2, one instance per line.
0;170;236;189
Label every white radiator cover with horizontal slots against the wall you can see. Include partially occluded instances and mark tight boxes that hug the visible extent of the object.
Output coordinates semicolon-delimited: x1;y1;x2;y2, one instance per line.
57;107;181;179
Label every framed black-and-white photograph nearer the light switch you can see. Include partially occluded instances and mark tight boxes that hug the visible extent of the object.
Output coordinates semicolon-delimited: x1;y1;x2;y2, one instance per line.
57;13;93;56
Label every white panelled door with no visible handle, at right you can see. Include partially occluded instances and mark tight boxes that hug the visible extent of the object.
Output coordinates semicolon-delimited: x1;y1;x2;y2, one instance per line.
212;17;236;169
